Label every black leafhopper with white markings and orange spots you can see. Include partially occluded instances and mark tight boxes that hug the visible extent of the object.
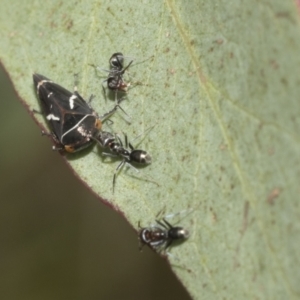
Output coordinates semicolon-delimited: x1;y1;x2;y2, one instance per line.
33;74;119;153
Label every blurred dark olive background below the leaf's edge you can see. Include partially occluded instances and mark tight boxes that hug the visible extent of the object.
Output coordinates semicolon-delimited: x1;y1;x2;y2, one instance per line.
0;67;190;300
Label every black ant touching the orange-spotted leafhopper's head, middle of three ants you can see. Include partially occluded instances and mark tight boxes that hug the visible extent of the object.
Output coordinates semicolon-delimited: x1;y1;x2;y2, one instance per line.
96;131;151;191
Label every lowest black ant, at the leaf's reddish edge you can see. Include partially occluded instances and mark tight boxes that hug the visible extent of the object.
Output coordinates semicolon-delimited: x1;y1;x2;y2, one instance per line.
139;218;189;253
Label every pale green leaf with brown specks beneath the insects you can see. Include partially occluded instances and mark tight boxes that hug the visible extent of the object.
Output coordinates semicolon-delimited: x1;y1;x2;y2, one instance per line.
0;0;300;299
